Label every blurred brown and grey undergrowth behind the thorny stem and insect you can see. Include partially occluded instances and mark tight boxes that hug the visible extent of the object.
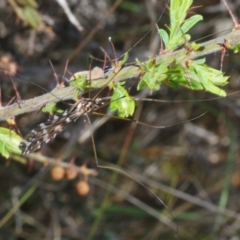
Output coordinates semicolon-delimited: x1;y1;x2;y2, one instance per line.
0;0;240;240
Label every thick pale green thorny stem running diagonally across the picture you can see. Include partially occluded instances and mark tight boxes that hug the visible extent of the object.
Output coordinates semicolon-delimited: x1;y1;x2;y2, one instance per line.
0;30;240;121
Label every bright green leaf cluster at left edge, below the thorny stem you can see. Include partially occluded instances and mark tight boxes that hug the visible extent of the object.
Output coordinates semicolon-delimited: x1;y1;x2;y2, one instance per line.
0;127;22;158
